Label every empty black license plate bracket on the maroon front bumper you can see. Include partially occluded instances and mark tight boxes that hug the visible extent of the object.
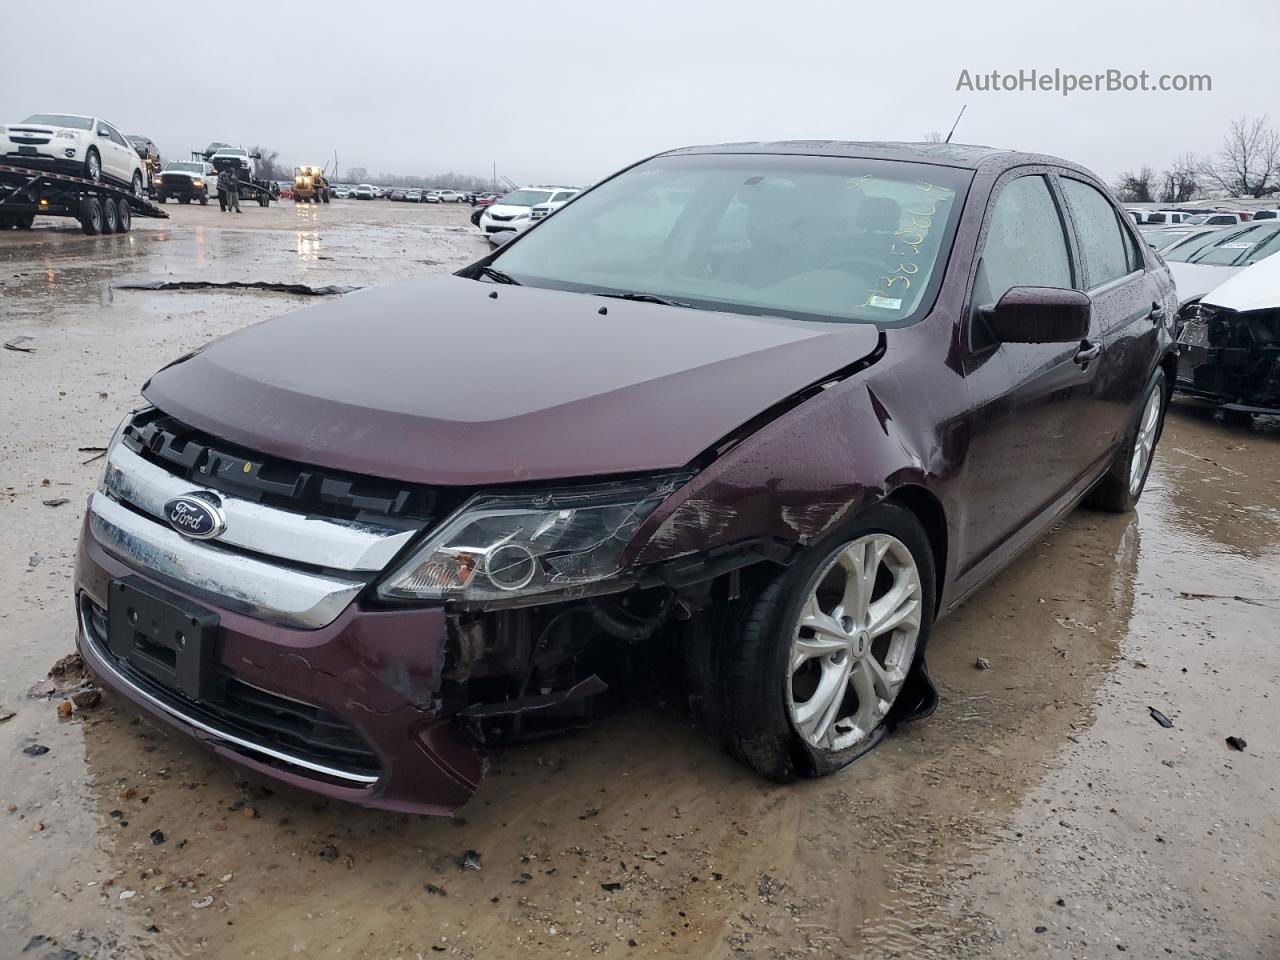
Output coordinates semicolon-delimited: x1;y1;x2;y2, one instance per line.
106;576;223;700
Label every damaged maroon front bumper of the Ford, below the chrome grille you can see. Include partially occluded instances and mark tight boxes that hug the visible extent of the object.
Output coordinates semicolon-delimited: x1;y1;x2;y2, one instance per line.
76;520;485;815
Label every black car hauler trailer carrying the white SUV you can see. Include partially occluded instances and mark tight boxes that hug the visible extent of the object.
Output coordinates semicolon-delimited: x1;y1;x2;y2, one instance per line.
0;164;168;236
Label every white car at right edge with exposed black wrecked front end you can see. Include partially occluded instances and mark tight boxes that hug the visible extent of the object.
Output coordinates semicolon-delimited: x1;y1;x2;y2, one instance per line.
1176;252;1280;415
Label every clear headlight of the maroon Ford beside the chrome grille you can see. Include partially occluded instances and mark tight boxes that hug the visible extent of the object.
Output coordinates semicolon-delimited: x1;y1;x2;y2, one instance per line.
378;475;687;605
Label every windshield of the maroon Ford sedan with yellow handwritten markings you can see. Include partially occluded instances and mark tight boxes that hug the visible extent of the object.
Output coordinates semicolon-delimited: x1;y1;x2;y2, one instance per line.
494;154;972;324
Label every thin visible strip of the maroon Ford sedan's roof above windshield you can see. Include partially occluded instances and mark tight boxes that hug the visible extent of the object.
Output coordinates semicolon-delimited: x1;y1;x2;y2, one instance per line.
658;140;1092;175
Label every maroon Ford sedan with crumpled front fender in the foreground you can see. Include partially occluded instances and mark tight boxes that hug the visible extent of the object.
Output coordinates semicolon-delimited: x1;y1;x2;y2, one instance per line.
76;141;1176;813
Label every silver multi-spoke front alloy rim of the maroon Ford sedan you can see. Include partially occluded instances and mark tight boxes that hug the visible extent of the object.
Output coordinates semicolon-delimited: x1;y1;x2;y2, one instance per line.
787;532;923;753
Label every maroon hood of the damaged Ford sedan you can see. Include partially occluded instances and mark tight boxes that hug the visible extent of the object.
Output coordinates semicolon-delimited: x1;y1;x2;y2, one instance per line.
143;276;879;485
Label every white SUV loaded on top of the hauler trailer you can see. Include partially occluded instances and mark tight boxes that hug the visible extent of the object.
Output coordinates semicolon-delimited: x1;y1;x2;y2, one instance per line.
0;114;146;197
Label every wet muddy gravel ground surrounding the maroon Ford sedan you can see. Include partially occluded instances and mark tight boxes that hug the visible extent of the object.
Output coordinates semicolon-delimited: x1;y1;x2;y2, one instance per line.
0;201;1280;960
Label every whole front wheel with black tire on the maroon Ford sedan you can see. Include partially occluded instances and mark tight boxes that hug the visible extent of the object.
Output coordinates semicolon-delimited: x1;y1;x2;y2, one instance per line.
712;503;936;782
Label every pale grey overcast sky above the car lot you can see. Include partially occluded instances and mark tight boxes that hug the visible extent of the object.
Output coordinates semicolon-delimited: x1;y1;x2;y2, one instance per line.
0;0;1280;184
